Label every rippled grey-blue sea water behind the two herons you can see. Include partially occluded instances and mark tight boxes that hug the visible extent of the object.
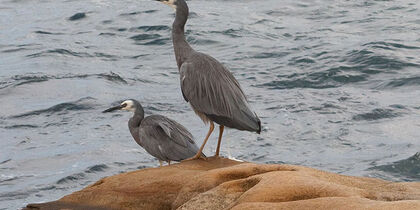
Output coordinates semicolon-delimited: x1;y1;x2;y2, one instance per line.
0;0;420;209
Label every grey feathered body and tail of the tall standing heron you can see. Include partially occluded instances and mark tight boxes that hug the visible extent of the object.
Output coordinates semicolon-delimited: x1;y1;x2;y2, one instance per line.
180;53;261;132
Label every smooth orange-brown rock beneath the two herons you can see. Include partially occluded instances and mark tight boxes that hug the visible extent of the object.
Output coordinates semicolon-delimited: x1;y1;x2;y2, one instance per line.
26;158;420;210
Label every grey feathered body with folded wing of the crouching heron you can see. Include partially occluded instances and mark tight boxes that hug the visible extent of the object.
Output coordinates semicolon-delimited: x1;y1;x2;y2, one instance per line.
139;115;198;161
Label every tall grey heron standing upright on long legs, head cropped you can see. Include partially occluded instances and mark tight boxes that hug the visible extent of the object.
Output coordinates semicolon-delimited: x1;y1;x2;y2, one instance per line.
157;0;261;159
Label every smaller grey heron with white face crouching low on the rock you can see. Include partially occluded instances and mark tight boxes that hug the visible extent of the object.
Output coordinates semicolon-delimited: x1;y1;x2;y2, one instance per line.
103;99;204;166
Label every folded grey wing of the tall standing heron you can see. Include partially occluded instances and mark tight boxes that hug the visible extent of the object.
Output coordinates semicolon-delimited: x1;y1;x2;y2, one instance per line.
180;56;252;118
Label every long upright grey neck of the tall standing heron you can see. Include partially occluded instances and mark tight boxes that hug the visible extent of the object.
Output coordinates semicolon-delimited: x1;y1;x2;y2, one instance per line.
172;0;193;69
